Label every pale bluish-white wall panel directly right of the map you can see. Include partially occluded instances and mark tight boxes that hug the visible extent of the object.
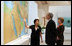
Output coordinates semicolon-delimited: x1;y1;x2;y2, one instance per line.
28;1;38;34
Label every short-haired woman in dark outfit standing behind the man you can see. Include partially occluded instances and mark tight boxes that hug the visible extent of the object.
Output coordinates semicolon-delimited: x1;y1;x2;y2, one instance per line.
57;17;65;45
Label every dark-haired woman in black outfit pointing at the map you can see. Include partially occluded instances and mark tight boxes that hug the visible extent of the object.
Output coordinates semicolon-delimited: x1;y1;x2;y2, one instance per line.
24;18;43;45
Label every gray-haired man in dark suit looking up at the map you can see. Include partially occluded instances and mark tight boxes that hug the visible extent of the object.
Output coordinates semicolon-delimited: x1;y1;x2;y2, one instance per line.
45;13;56;45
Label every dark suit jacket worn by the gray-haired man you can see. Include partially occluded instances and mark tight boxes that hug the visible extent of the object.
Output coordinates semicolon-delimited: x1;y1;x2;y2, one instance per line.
45;19;57;44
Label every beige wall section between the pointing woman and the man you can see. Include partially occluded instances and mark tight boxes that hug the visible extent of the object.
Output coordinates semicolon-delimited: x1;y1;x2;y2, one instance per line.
38;5;48;27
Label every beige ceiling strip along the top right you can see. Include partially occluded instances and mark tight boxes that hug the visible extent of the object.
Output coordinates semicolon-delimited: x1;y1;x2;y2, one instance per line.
35;1;71;6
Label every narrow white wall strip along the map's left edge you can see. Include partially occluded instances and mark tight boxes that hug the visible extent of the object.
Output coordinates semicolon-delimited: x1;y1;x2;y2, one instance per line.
1;1;4;45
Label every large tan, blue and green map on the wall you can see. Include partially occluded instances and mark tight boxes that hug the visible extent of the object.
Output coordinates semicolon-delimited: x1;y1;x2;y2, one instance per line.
4;1;28;44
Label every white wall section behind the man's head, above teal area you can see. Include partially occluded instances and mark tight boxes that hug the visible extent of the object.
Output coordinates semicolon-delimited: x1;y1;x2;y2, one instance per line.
49;5;71;24
